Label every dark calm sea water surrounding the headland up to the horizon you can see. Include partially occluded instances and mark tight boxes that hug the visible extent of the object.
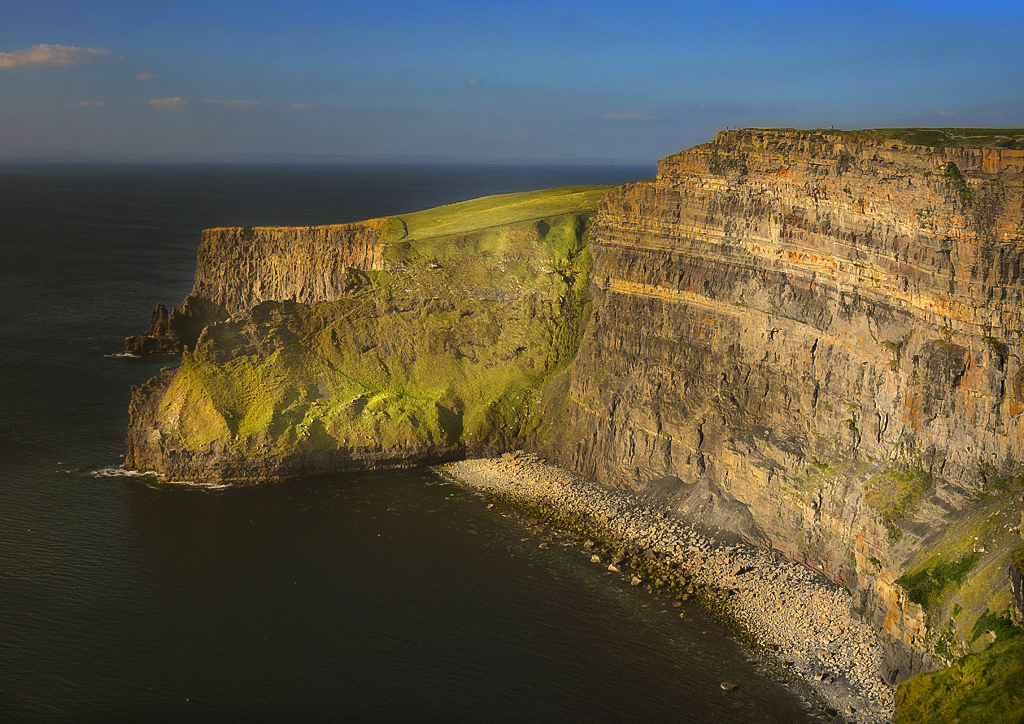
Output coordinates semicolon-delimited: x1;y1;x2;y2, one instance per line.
0;165;804;723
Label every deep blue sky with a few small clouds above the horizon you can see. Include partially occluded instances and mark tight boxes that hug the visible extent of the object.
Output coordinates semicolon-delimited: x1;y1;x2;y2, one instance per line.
0;0;1024;162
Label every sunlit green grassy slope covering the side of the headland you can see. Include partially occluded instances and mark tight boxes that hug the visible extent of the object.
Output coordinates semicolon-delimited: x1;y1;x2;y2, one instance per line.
154;186;606;456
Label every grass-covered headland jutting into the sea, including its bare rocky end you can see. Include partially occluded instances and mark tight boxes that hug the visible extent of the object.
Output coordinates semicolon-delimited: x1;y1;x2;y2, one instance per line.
125;187;607;482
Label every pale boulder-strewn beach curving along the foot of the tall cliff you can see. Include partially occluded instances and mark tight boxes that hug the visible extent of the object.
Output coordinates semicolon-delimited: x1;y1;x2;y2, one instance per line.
438;452;894;722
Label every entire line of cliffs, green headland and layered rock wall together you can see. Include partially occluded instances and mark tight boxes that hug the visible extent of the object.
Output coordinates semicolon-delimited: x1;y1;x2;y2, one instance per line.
126;129;1024;724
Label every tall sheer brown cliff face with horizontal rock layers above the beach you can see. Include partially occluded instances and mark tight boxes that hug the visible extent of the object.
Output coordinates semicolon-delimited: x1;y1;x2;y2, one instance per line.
561;131;1024;679
